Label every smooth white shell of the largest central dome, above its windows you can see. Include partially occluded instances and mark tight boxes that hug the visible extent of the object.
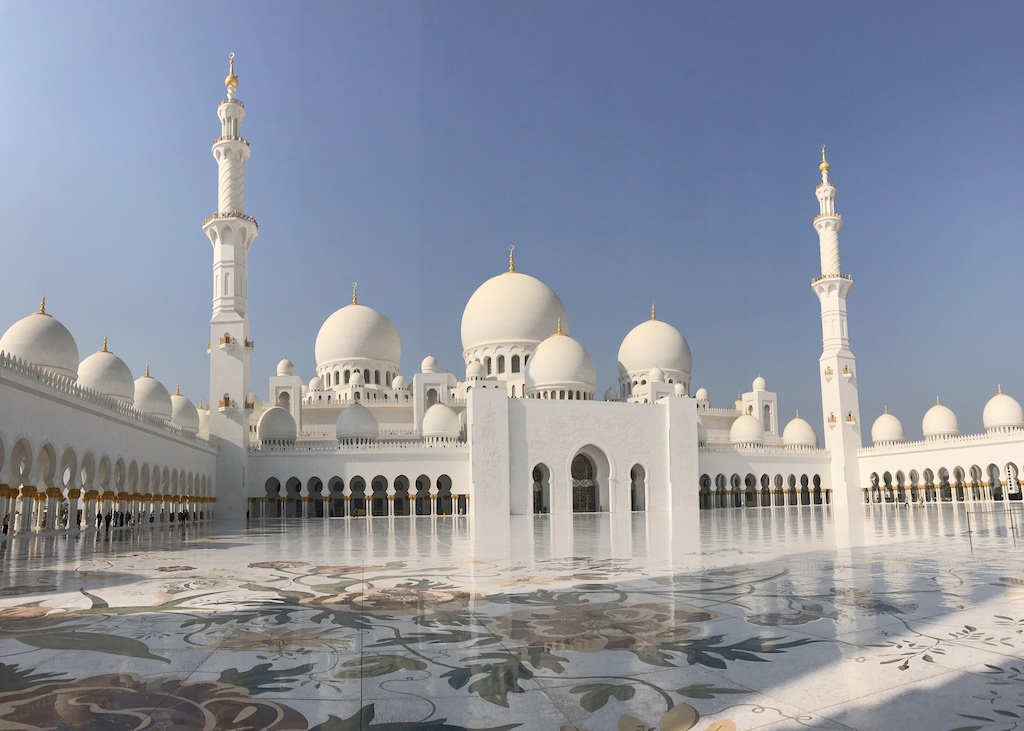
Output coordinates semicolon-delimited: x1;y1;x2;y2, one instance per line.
462;271;569;352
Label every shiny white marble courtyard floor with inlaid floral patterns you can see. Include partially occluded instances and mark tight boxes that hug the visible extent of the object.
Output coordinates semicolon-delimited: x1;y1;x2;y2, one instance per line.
0;504;1024;731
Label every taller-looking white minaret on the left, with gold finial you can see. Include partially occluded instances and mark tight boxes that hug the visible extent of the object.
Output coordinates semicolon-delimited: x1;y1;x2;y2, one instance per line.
203;53;258;519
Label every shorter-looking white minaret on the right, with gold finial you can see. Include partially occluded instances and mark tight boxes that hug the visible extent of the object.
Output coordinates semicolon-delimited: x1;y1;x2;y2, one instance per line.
811;144;861;506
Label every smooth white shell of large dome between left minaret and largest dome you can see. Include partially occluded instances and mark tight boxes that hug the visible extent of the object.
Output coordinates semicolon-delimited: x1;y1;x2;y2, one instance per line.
315;304;401;369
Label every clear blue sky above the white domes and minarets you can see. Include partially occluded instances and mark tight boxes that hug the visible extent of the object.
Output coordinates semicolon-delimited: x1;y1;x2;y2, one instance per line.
0;0;1024;438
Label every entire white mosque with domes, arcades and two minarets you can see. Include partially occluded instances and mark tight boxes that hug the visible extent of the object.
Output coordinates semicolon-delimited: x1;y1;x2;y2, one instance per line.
0;60;1024;531
